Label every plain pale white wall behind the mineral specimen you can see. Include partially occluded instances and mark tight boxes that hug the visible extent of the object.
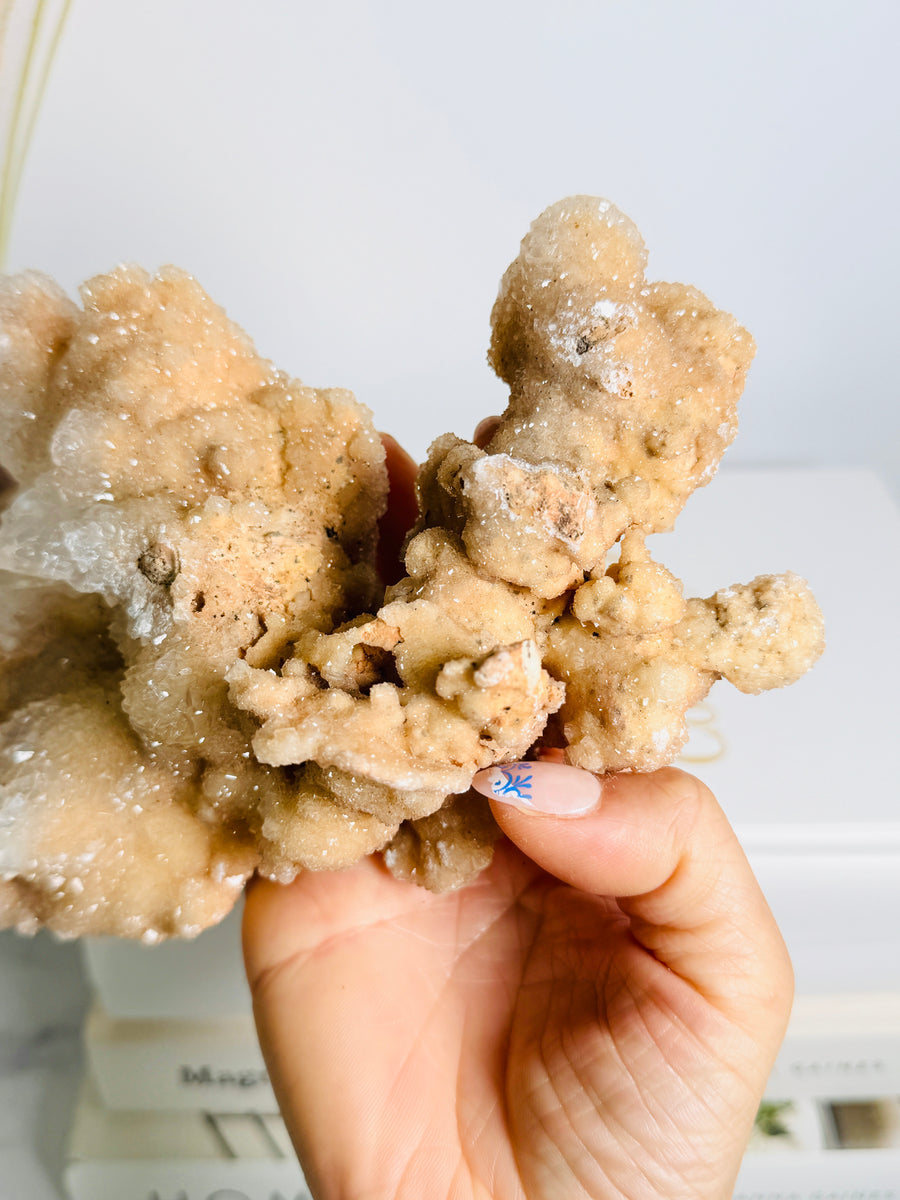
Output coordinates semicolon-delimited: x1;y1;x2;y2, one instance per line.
8;0;900;491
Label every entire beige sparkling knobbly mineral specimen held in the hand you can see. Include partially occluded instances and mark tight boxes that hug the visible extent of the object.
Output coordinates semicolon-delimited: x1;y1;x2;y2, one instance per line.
0;197;822;941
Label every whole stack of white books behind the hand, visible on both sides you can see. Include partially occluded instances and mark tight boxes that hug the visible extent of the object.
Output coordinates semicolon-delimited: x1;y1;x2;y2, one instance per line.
67;469;900;1200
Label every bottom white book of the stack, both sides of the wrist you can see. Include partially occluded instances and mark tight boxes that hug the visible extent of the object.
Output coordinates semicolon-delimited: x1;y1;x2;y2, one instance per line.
64;1082;900;1200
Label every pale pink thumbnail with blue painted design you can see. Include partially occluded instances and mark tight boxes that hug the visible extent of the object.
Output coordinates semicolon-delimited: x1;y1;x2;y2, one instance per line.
472;762;601;817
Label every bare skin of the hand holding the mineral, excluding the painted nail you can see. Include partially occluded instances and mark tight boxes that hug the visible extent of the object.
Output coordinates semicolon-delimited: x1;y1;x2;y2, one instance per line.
244;431;793;1200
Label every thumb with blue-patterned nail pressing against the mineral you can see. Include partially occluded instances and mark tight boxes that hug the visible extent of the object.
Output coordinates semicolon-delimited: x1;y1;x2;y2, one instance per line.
474;762;793;1025
